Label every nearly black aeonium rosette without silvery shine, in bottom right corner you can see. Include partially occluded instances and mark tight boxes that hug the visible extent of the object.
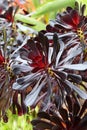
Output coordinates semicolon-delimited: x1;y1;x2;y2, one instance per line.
32;95;87;130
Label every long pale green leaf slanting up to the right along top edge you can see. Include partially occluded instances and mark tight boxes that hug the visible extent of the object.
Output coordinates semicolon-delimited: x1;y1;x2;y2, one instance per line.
32;0;75;17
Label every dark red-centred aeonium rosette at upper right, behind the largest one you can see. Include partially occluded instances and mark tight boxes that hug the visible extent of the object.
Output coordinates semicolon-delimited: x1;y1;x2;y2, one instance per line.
44;2;87;46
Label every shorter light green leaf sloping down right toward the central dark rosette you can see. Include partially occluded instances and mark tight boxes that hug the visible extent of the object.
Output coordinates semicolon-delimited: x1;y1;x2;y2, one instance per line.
15;14;46;31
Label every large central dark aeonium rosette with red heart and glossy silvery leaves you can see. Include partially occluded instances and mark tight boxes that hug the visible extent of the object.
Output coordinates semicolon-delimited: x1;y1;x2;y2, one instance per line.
13;32;87;110
